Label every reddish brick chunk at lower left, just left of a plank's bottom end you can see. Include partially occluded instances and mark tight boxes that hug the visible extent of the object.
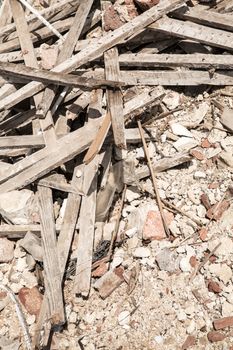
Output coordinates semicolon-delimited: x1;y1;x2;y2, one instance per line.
18;287;43;317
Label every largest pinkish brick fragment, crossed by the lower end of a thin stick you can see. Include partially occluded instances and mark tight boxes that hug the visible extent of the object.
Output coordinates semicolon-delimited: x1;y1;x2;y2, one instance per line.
142;210;174;241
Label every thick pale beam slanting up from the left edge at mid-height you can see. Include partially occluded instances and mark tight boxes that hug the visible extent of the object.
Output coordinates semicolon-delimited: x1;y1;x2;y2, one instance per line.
0;124;97;192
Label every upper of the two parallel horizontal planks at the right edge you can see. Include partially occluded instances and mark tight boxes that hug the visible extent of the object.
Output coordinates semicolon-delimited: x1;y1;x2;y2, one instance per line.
119;53;233;70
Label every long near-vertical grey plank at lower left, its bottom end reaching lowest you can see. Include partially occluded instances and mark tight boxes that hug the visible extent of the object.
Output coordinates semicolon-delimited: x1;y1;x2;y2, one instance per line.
38;186;65;325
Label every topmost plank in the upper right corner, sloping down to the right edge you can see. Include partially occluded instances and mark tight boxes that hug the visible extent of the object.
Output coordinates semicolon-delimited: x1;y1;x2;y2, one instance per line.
172;7;233;32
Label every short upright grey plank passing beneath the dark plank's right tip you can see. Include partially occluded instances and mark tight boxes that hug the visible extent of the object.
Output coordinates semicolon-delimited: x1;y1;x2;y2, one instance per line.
104;47;126;148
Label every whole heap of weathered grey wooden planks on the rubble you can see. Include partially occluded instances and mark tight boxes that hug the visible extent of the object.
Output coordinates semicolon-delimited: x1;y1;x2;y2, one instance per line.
0;0;233;347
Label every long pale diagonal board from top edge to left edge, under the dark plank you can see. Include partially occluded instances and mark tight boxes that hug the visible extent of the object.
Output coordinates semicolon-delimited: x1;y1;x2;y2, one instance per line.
0;0;185;110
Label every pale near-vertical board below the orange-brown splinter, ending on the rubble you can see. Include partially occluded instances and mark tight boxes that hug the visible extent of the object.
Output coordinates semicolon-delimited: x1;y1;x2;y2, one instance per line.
74;158;98;297
